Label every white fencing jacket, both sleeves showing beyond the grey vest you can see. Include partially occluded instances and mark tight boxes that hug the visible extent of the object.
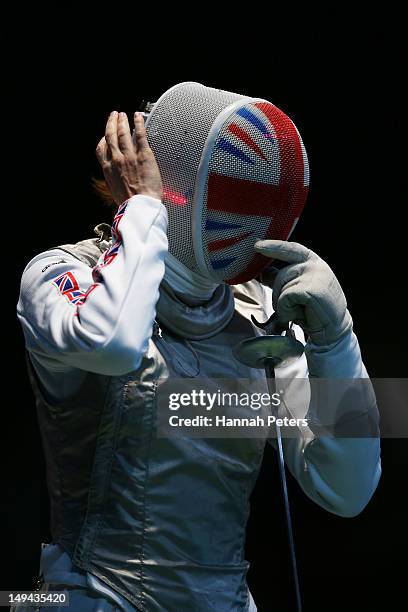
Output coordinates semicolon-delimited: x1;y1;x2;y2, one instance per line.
17;195;381;608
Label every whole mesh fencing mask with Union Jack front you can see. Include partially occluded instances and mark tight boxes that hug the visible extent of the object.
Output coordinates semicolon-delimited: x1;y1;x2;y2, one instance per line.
146;83;309;284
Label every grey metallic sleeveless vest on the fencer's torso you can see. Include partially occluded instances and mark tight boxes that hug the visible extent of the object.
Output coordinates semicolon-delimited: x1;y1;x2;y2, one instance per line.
29;239;265;612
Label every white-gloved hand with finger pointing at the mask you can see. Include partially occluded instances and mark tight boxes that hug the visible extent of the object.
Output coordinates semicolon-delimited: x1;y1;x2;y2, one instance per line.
254;240;353;345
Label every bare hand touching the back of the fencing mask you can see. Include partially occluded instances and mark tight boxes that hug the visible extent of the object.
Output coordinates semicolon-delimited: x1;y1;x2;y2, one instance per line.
96;111;163;206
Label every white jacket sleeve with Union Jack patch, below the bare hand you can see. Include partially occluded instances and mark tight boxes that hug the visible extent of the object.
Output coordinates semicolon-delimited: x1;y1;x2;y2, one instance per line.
17;195;168;376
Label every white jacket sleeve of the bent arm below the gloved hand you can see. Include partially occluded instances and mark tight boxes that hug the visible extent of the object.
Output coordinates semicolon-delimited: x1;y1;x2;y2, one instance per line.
264;287;381;517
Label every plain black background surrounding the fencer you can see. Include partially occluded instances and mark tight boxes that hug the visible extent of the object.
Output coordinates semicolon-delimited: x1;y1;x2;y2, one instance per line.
1;16;408;612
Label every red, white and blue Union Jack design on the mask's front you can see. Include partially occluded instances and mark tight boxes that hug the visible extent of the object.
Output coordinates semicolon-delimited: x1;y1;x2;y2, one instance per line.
203;102;308;284
